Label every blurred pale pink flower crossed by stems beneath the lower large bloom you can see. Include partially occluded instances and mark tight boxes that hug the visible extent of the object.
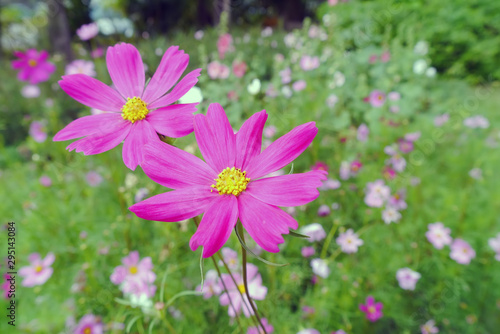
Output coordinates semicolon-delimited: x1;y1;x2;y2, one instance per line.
219;263;267;318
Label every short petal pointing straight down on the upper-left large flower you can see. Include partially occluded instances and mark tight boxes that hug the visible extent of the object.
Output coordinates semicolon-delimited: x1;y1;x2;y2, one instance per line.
122;120;160;170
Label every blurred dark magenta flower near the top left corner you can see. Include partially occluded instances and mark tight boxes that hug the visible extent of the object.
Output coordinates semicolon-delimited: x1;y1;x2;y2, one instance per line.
12;49;56;85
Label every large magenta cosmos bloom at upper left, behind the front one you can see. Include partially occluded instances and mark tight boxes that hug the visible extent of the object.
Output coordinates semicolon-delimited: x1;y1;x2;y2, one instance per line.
54;43;201;170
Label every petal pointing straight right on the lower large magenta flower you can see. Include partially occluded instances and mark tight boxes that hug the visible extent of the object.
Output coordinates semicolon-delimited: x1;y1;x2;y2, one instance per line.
247;170;326;206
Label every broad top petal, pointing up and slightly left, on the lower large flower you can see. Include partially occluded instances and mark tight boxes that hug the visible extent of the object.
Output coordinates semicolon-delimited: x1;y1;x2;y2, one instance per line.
194;103;236;172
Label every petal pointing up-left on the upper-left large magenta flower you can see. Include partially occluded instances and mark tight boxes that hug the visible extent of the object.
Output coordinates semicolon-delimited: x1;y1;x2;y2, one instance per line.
59;74;125;111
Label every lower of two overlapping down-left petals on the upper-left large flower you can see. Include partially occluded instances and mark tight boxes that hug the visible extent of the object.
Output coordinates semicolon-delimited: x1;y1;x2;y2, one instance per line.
67;119;132;155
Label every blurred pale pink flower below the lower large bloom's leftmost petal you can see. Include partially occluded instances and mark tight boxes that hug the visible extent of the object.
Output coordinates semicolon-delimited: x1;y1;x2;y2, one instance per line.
110;251;156;298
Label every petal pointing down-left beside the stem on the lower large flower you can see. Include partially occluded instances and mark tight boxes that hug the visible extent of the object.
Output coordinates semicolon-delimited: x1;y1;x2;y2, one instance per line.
189;195;238;258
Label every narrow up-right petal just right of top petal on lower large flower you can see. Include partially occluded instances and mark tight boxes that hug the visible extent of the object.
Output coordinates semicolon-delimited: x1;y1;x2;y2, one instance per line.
235;110;267;170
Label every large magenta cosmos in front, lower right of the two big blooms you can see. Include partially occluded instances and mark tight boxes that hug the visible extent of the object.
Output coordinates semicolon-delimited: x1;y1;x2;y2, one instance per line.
130;103;326;257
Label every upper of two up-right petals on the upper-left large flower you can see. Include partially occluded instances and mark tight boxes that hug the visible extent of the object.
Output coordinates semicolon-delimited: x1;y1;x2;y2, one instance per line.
143;46;189;103
